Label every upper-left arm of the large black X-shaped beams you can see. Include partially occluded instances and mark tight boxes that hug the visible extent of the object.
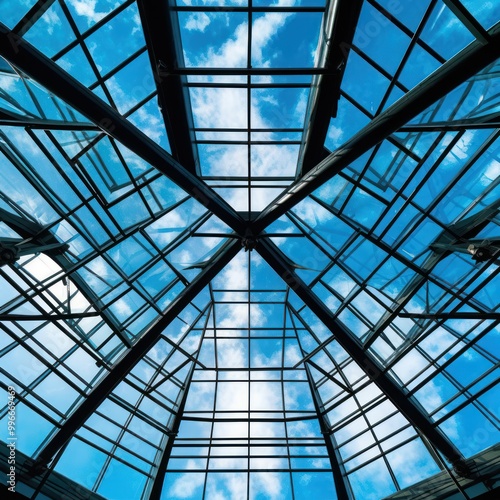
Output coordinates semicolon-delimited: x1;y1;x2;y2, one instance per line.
0;23;246;234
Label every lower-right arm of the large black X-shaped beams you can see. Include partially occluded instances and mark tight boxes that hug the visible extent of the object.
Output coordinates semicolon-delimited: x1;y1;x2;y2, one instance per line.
256;239;465;470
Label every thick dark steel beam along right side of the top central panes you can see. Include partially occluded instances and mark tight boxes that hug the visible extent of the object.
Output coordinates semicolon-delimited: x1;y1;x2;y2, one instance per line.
298;0;363;175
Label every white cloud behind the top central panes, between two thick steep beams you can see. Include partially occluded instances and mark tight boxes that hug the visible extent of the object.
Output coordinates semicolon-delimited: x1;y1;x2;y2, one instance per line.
185;0;307;210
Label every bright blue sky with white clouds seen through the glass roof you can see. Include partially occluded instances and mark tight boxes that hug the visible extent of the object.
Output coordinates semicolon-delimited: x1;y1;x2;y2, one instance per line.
0;0;500;500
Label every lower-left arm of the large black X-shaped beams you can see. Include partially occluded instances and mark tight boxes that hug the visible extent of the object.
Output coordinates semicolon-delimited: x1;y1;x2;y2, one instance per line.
33;240;241;472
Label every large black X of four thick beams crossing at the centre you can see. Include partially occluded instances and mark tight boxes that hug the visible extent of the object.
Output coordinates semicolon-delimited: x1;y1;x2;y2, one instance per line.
0;20;500;484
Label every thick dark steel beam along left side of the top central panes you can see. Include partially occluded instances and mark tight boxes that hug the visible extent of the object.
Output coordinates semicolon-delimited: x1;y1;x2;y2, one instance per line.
137;0;200;175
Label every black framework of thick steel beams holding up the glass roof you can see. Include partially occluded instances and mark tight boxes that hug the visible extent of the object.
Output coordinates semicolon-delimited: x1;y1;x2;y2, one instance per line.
0;0;500;500
